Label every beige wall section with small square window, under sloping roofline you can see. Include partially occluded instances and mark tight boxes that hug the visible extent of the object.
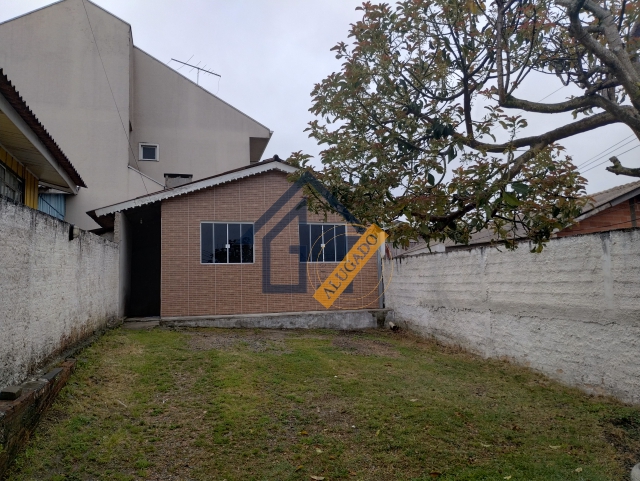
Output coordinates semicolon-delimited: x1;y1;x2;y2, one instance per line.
132;48;269;185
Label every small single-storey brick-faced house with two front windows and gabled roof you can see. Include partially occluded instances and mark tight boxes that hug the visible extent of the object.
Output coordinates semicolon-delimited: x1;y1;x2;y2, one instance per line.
89;160;380;317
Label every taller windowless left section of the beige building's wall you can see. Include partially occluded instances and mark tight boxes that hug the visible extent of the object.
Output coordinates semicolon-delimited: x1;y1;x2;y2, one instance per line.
0;0;131;228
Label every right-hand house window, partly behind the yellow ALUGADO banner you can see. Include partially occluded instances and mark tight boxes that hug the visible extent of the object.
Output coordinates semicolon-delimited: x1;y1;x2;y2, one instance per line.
299;224;347;262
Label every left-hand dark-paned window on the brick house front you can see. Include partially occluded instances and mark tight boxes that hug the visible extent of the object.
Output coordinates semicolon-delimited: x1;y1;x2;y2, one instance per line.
200;222;253;264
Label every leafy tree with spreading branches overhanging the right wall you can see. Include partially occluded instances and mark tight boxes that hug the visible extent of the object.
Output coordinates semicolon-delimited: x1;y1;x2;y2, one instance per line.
290;0;640;251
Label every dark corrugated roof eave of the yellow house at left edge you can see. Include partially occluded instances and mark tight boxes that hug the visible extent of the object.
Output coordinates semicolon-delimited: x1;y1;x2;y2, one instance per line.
0;69;86;188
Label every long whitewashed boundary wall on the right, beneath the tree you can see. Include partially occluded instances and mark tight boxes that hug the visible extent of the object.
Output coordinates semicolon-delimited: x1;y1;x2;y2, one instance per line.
385;230;640;403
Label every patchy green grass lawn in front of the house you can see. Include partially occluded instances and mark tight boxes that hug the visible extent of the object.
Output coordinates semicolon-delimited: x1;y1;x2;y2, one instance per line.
8;329;640;481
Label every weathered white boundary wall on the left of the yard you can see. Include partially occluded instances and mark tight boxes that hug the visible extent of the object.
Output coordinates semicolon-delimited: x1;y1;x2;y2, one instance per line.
0;199;119;387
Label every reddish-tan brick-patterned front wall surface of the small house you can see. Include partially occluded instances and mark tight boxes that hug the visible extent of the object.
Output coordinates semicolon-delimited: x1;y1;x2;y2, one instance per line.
161;172;378;317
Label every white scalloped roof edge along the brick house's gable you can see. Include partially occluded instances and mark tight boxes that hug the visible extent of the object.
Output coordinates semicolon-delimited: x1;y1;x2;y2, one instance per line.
87;159;298;225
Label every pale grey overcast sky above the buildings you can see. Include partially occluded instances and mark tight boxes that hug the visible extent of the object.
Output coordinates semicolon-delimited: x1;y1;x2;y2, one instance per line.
0;0;640;193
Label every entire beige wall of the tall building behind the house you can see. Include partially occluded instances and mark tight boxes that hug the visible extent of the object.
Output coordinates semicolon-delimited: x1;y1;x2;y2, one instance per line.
0;0;270;229
